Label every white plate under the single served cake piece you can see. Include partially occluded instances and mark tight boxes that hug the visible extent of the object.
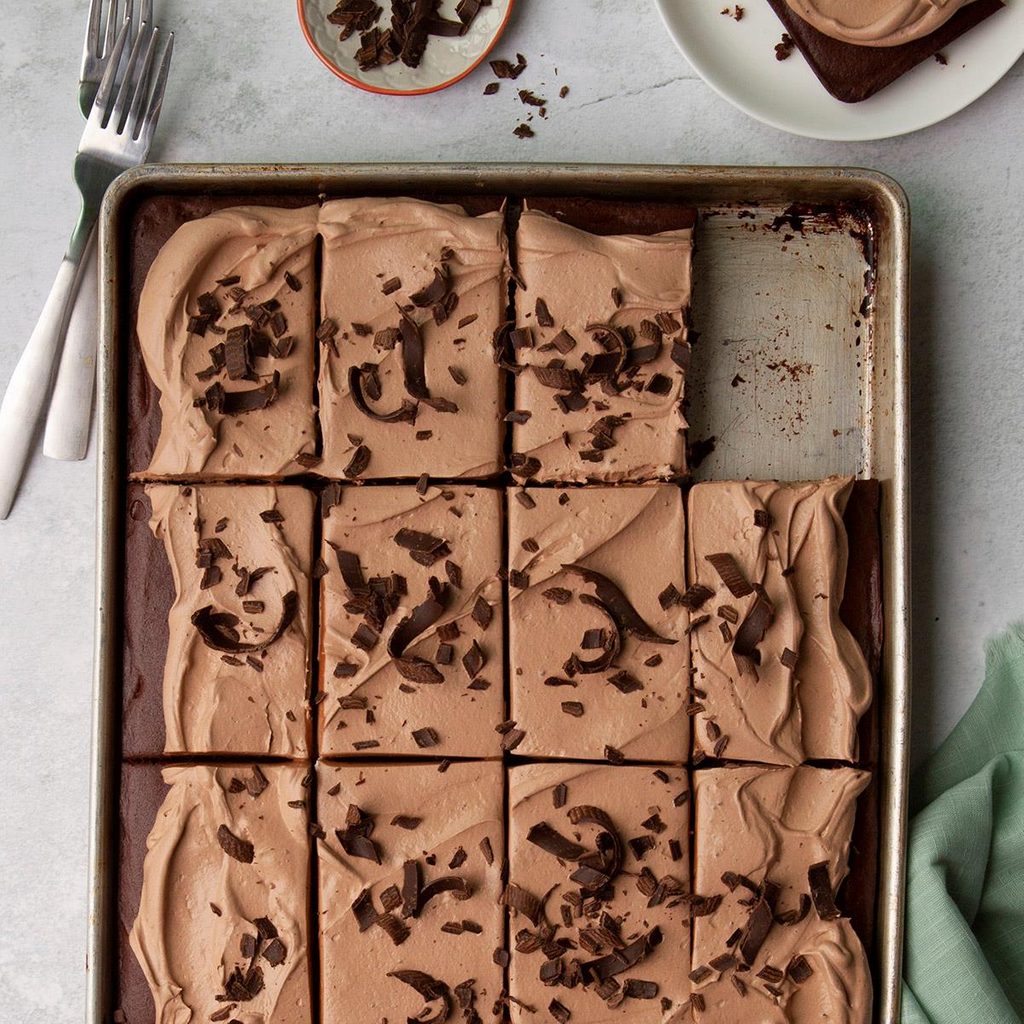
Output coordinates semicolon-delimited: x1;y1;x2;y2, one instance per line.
654;0;1024;142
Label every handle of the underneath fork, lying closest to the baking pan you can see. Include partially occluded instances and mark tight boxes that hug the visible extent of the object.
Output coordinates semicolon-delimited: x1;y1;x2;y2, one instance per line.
43;236;99;462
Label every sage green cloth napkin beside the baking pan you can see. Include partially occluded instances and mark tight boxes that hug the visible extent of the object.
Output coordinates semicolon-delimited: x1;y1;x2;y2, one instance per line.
902;625;1024;1024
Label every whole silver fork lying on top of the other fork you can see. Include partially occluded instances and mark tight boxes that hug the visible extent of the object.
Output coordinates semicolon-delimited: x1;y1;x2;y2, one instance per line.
0;12;174;519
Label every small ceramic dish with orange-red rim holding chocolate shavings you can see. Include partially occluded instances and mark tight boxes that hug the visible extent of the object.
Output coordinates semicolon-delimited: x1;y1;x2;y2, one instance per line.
298;0;514;96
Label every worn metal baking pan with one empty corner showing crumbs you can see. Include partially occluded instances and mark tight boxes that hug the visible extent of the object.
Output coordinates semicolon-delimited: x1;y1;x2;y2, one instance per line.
86;164;910;1024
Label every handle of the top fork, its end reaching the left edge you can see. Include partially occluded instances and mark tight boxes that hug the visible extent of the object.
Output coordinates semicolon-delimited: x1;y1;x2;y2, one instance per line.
0;256;79;519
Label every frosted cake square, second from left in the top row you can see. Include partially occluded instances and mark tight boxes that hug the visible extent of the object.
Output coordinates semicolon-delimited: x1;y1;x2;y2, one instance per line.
319;199;508;478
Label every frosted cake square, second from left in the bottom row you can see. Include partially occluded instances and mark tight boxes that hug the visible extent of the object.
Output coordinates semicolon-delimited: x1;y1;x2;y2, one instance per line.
317;761;505;1022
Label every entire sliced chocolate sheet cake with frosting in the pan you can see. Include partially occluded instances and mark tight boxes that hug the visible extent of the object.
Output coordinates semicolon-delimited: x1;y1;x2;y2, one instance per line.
118;192;888;1024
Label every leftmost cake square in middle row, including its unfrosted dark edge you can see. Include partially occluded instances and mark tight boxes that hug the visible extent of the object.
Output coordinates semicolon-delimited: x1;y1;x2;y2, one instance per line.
124;483;314;758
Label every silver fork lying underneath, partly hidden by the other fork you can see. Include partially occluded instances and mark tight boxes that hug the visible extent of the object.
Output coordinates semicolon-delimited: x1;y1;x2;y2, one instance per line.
43;0;154;462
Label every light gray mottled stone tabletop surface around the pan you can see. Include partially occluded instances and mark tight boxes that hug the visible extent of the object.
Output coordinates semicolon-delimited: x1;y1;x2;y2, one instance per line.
0;0;1024;1024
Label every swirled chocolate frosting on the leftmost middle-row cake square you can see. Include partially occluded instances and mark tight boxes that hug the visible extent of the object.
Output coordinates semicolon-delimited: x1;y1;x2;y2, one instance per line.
146;484;313;757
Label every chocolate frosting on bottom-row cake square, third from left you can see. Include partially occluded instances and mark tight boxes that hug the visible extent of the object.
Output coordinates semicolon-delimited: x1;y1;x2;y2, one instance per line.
509;764;690;1024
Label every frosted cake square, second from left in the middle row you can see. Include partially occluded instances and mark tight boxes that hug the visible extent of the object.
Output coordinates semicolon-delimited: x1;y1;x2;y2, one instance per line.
319;484;505;757
